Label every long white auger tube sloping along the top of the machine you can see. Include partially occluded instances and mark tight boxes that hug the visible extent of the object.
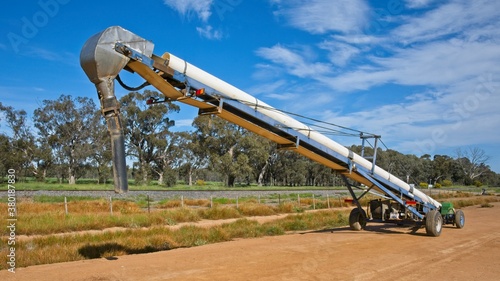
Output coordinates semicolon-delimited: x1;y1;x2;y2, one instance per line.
168;54;441;208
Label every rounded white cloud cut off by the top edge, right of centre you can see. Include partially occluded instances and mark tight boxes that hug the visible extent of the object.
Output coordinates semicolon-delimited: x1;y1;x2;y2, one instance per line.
272;0;369;34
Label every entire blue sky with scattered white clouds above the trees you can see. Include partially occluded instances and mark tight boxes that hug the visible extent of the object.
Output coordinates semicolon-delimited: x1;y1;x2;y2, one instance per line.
0;0;500;172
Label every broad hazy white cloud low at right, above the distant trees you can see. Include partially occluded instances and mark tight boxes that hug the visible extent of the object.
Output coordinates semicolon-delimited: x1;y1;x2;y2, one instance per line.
325;77;500;155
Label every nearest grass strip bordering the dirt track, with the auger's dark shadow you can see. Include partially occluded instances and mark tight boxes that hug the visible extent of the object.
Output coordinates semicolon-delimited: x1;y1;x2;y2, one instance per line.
0;210;347;269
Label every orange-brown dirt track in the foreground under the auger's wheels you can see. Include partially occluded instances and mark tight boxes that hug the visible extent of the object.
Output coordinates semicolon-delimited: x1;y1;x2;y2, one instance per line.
0;203;500;281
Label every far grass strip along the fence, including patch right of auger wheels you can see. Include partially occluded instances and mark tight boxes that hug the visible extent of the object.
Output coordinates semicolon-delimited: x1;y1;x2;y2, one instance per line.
0;189;490;235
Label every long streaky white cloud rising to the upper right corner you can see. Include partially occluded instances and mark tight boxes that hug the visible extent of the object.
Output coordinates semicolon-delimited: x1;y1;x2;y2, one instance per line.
257;0;500;92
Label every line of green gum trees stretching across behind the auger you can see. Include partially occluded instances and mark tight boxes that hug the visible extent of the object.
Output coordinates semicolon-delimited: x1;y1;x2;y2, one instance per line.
0;90;500;186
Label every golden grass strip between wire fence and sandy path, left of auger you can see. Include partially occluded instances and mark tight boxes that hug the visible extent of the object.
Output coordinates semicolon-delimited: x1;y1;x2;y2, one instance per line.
0;198;312;235
